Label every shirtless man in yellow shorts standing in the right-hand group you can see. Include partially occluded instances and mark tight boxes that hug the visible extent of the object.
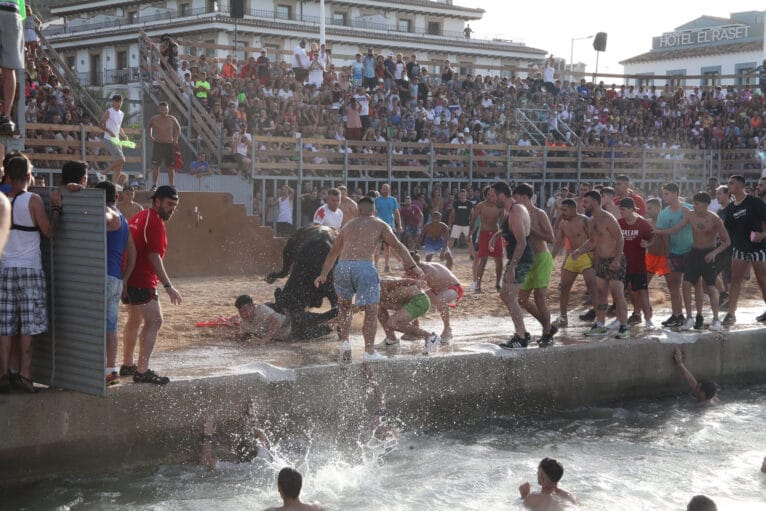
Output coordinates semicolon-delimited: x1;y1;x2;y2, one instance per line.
551;199;596;328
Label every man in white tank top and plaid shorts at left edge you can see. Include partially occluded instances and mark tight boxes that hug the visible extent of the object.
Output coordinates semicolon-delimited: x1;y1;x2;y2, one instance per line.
0;155;63;393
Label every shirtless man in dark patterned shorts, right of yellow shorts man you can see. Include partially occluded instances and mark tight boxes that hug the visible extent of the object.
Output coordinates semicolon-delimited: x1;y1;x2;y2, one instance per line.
572;190;630;339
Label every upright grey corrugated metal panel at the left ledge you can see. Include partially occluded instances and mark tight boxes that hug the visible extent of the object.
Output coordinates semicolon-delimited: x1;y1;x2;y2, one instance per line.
33;190;106;395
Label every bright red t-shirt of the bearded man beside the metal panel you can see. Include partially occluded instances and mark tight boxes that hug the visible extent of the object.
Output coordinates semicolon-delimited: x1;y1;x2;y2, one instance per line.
128;208;168;289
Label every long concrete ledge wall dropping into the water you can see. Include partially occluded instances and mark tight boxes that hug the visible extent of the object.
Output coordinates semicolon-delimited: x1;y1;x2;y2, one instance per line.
0;329;766;481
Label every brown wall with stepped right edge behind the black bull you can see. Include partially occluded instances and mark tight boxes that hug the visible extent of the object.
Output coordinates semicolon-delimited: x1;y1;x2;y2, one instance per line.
136;192;284;278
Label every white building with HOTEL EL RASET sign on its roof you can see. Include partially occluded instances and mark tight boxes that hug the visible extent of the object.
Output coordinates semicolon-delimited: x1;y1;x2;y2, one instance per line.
620;11;766;87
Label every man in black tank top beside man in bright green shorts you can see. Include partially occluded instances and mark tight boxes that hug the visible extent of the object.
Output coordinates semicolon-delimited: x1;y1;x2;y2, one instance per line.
490;181;534;349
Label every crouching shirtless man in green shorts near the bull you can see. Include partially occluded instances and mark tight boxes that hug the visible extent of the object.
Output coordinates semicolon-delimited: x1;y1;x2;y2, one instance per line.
378;277;441;355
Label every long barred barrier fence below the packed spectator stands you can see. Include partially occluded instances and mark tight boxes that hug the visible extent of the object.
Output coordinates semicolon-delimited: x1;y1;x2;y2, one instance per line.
250;136;766;230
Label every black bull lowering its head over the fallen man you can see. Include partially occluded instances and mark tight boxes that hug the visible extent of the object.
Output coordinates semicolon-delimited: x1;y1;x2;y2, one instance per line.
266;225;338;311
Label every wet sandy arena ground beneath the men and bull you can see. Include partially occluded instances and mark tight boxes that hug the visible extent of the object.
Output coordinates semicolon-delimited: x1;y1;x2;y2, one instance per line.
118;250;763;378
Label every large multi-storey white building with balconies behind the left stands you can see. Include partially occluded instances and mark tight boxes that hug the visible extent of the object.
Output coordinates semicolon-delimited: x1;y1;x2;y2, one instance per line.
44;0;546;99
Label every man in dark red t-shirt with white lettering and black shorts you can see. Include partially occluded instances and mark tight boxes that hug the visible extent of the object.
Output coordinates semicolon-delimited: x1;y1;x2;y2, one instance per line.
617;197;655;330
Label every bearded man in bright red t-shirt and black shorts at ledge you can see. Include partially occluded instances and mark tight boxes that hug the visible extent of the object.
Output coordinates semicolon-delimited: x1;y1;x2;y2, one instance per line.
120;185;181;385
